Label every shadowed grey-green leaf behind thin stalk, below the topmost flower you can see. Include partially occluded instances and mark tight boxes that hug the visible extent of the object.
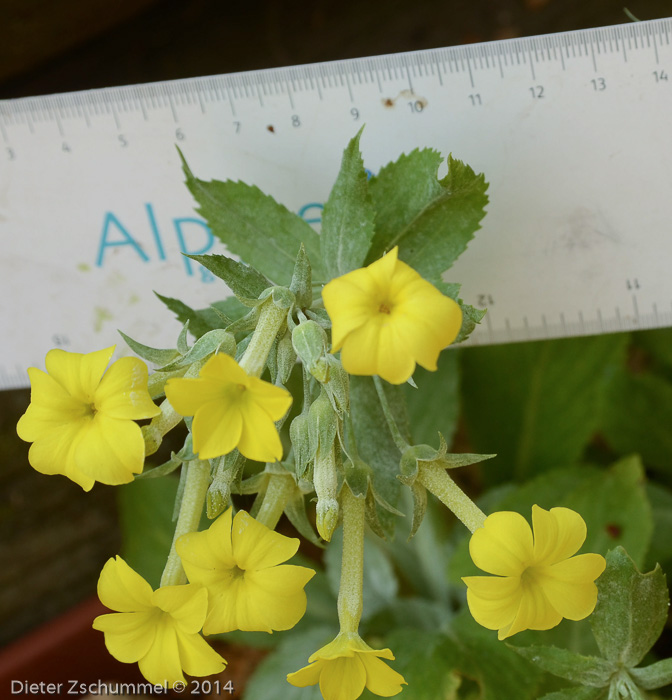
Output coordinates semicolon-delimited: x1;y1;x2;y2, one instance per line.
350;377;408;537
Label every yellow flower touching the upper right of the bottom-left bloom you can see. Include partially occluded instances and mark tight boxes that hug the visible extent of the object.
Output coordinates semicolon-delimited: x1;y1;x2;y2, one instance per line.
176;508;315;634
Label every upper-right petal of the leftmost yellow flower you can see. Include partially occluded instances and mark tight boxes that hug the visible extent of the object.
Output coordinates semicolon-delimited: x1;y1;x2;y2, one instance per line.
94;357;161;420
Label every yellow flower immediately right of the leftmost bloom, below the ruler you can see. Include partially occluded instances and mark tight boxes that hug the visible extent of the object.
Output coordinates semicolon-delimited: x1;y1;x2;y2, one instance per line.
166;354;292;462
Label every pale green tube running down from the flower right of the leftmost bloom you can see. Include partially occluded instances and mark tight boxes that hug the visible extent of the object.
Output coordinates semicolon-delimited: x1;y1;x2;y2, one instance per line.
161;459;210;586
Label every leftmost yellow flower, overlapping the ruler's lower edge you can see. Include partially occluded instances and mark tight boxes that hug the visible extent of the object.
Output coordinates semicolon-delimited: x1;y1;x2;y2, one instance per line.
16;346;160;491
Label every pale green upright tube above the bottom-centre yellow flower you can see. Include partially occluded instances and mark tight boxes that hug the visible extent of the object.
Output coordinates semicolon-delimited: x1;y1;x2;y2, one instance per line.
338;484;365;634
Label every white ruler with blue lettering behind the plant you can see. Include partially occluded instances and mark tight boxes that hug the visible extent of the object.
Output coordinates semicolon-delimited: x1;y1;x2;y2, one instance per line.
0;19;672;388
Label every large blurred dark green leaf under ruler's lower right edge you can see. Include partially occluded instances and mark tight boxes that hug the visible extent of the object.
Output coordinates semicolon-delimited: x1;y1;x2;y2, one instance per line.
461;334;627;482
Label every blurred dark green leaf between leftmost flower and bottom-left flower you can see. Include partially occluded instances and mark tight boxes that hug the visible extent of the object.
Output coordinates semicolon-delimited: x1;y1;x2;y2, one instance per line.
118;477;177;588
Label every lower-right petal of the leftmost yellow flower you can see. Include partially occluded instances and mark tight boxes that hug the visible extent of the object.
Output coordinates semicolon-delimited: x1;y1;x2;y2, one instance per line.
74;413;145;485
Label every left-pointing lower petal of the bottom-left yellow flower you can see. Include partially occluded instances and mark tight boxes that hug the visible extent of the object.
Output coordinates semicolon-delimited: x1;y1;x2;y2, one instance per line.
93;610;158;664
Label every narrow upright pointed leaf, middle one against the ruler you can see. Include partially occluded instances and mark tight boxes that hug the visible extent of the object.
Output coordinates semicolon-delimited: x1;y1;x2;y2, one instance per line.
320;127;376;279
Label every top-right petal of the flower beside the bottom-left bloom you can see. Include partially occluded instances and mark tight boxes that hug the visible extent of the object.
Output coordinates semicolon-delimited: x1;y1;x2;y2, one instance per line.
232;510;299;571
